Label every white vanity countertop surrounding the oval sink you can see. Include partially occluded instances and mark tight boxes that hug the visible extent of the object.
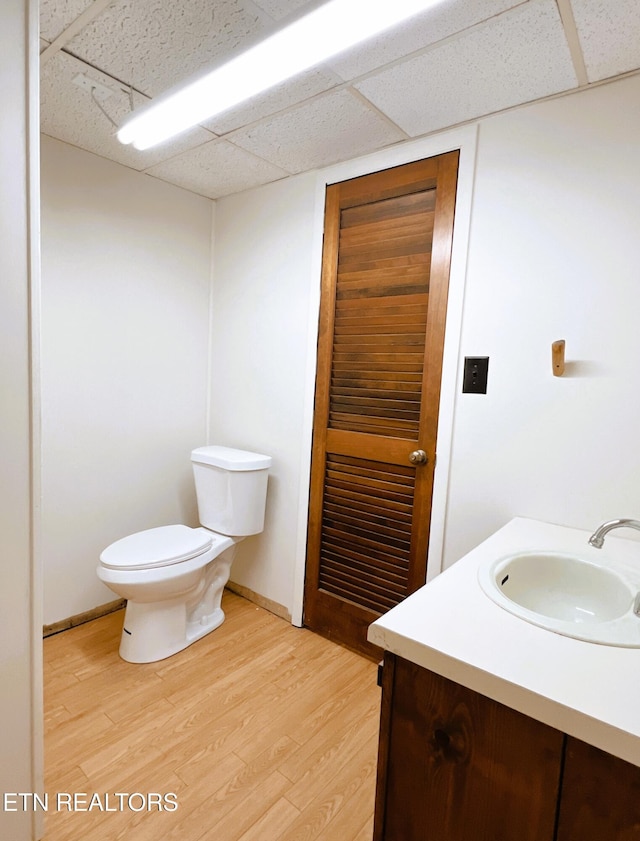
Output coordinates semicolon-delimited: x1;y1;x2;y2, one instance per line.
368;518;640;766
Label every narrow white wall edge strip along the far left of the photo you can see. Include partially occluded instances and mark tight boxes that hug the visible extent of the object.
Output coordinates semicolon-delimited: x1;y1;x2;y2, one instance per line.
0;0;42;841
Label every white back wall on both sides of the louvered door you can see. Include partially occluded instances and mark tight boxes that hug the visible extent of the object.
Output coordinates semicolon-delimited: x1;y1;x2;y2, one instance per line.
211;72;640;613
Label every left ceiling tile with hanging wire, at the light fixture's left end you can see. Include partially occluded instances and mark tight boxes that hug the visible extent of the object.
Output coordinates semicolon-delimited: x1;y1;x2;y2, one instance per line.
40;52;211;170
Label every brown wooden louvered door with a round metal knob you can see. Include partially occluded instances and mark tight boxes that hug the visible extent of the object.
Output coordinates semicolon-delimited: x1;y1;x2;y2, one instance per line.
304;152;458;656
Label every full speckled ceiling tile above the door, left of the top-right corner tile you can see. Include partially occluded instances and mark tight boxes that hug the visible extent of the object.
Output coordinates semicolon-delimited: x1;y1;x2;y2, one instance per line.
356;0;577;136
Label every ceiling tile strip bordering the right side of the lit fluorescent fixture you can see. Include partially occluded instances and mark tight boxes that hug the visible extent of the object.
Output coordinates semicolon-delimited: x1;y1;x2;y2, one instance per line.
331;0;526;81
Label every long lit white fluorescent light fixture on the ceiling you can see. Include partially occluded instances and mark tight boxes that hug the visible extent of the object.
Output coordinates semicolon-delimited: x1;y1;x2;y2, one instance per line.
118;0;443;149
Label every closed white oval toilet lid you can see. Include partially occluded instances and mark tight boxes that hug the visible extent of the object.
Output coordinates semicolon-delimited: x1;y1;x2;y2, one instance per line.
100;525;213;569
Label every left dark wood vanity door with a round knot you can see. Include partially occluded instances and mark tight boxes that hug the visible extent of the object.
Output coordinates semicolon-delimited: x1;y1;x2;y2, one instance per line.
376;655;564;841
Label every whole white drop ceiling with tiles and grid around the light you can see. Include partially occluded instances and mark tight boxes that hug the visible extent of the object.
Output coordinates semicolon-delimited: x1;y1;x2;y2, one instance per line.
40;0;640;199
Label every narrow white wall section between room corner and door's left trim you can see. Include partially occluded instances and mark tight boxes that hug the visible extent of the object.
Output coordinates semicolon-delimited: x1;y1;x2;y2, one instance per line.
209;174;319;610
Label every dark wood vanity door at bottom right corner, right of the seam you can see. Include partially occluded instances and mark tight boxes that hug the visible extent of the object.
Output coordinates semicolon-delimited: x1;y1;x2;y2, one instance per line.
558;736;640;841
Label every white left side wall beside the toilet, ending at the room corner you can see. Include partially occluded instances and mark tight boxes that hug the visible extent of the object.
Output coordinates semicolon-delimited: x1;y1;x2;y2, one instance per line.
42;137;213;623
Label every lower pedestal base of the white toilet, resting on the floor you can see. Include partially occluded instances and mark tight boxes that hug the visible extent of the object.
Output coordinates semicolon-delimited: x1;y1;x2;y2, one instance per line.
120;601;225;663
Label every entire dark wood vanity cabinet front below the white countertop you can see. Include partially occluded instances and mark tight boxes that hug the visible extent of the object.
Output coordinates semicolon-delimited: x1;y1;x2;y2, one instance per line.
374;653;640;841
